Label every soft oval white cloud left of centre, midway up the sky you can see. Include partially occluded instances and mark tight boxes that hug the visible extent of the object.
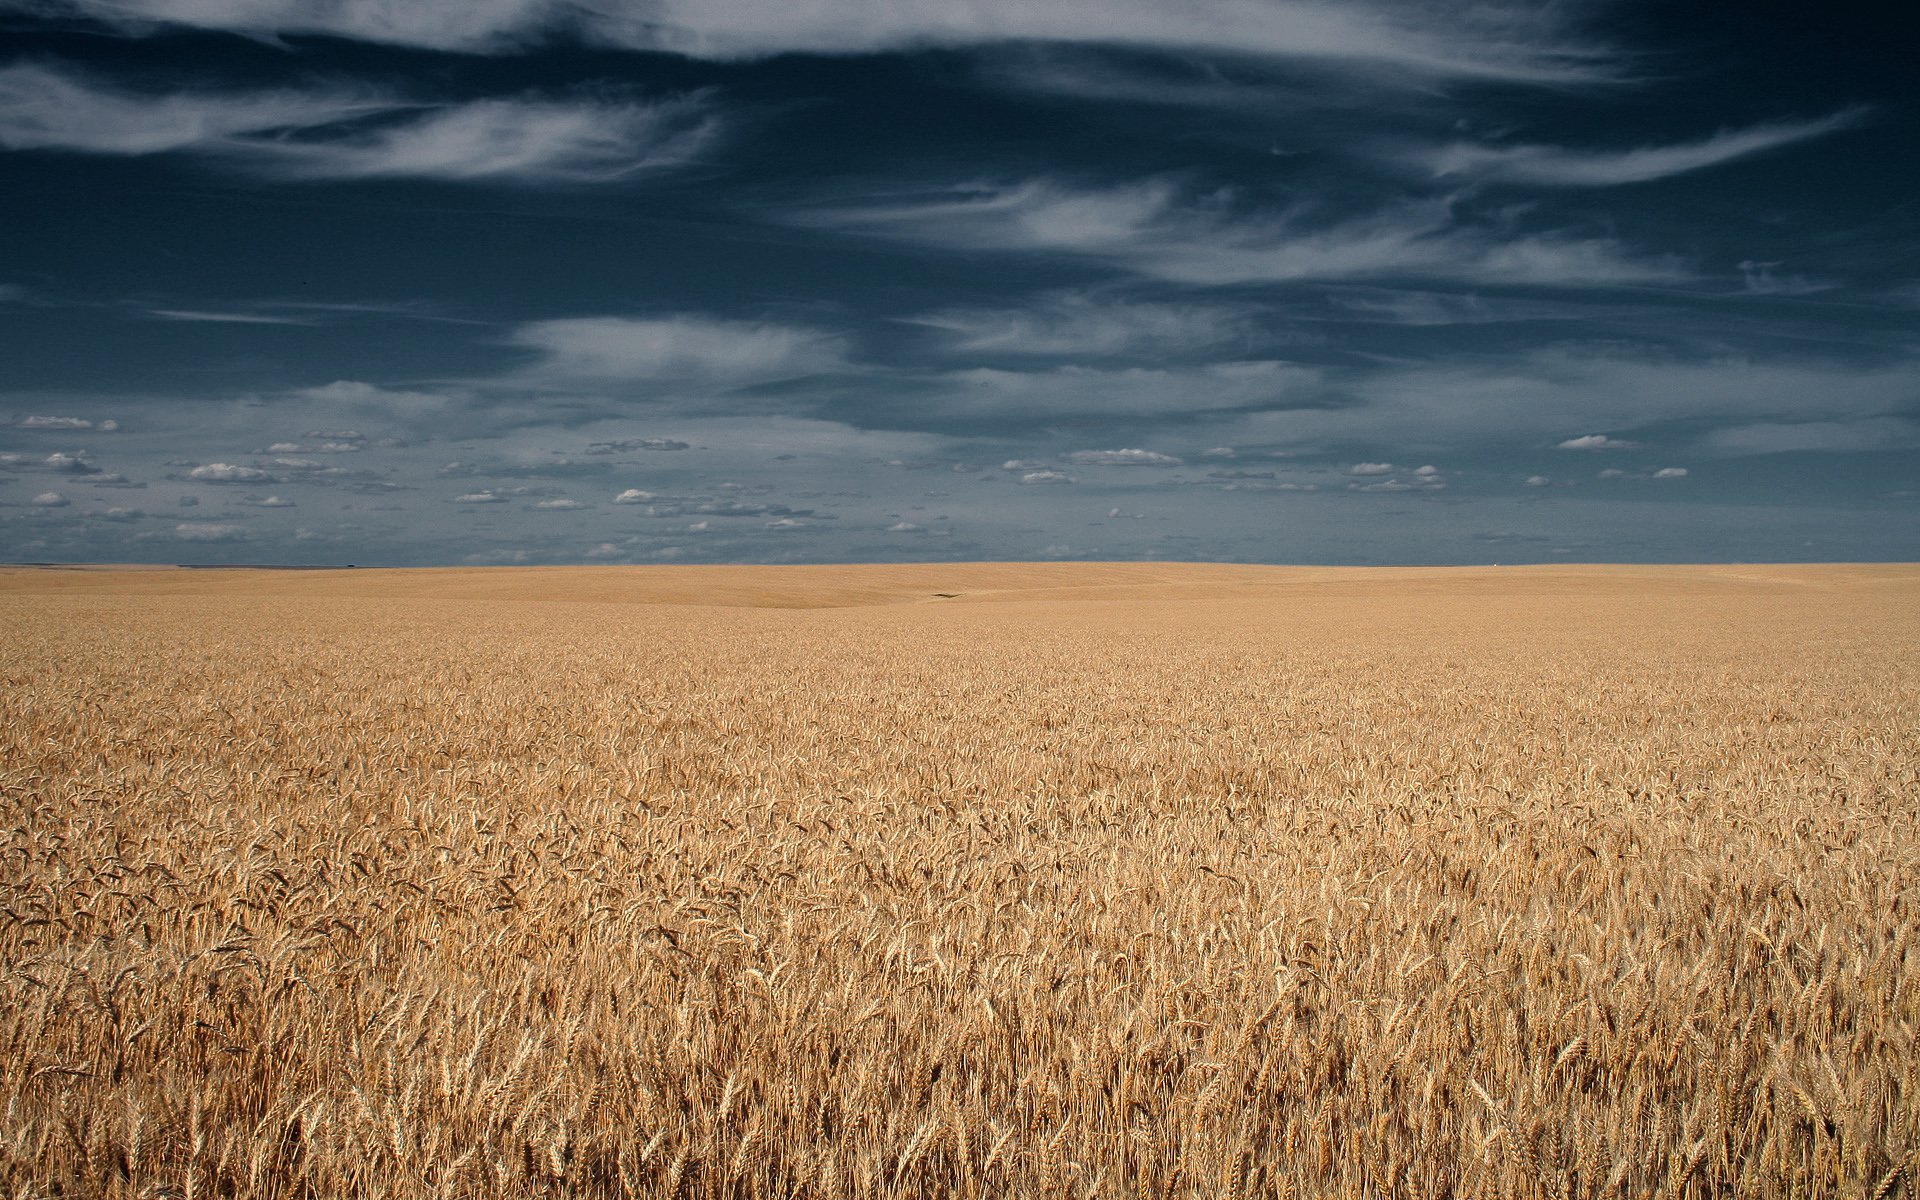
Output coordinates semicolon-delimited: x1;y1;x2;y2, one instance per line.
511;315;847;386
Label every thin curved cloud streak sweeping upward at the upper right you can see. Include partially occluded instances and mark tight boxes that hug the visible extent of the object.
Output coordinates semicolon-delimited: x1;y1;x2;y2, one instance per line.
1407;108;1868;188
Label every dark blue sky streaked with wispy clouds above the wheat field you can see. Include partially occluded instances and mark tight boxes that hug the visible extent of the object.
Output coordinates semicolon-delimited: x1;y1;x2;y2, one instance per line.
0;0;1920;566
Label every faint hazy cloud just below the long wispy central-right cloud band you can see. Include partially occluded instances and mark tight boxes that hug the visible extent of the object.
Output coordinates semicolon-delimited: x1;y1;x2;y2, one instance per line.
908;292;1252;357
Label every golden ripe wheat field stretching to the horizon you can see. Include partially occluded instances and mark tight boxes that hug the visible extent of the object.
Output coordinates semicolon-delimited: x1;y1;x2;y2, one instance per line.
0;564;1920;1200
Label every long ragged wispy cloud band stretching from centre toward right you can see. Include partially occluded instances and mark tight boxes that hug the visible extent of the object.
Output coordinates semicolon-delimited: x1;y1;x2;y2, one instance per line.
802;179;1690;286
